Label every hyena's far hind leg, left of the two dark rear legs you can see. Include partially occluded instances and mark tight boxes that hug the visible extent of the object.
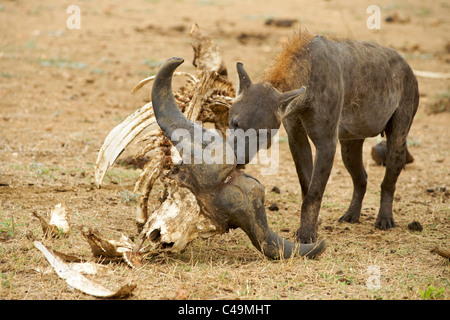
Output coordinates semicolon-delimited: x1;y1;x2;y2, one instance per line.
339;139;367;223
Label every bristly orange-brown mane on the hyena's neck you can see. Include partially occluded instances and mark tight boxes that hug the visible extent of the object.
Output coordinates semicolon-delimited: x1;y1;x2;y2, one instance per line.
262;31;315;92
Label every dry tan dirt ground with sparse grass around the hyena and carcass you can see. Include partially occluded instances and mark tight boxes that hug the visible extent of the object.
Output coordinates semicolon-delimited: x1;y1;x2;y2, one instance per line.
0;0;450;300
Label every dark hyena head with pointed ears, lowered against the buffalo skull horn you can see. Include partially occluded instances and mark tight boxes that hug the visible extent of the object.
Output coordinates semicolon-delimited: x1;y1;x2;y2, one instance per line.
228;62;305;164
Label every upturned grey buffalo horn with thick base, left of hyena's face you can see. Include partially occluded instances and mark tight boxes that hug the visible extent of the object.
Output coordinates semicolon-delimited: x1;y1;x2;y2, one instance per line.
152;57;236;191
